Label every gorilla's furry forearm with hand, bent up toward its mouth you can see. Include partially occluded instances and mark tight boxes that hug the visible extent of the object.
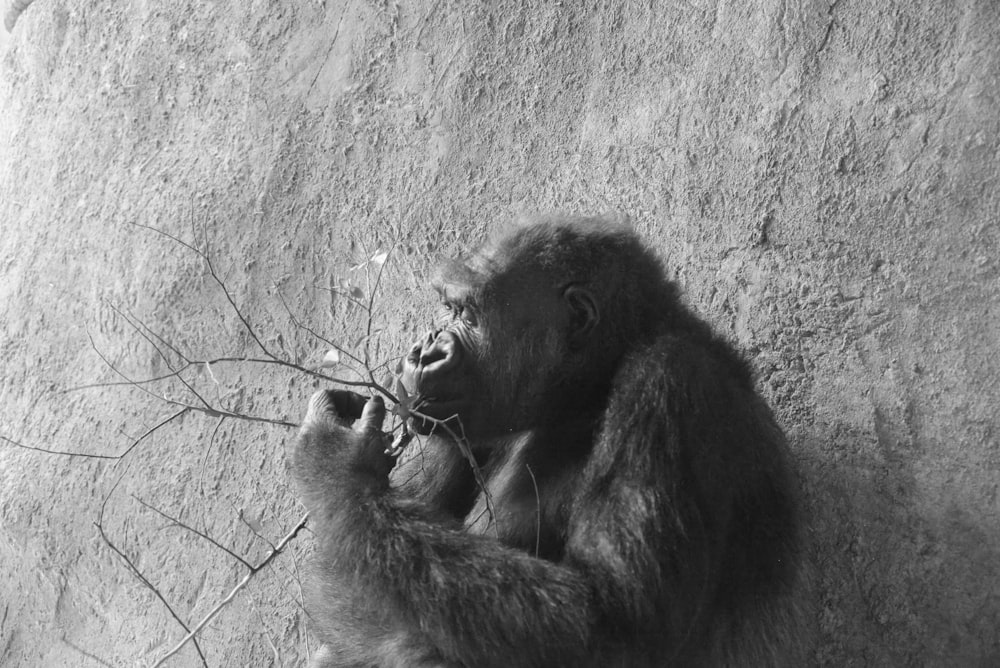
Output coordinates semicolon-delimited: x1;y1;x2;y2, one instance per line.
293;394;596;666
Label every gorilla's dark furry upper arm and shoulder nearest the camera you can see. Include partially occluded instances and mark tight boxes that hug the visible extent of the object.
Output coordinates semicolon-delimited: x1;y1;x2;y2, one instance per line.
567;337;739;648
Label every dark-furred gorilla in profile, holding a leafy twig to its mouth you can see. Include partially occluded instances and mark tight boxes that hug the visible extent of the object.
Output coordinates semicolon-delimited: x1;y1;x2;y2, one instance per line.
291;217;802;667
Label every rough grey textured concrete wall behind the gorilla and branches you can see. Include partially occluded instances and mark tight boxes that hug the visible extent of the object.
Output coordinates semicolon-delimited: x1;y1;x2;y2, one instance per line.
0;0;1000;666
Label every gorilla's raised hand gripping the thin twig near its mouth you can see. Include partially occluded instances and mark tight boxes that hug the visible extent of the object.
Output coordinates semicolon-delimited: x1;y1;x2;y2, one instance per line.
295;390;393;480
